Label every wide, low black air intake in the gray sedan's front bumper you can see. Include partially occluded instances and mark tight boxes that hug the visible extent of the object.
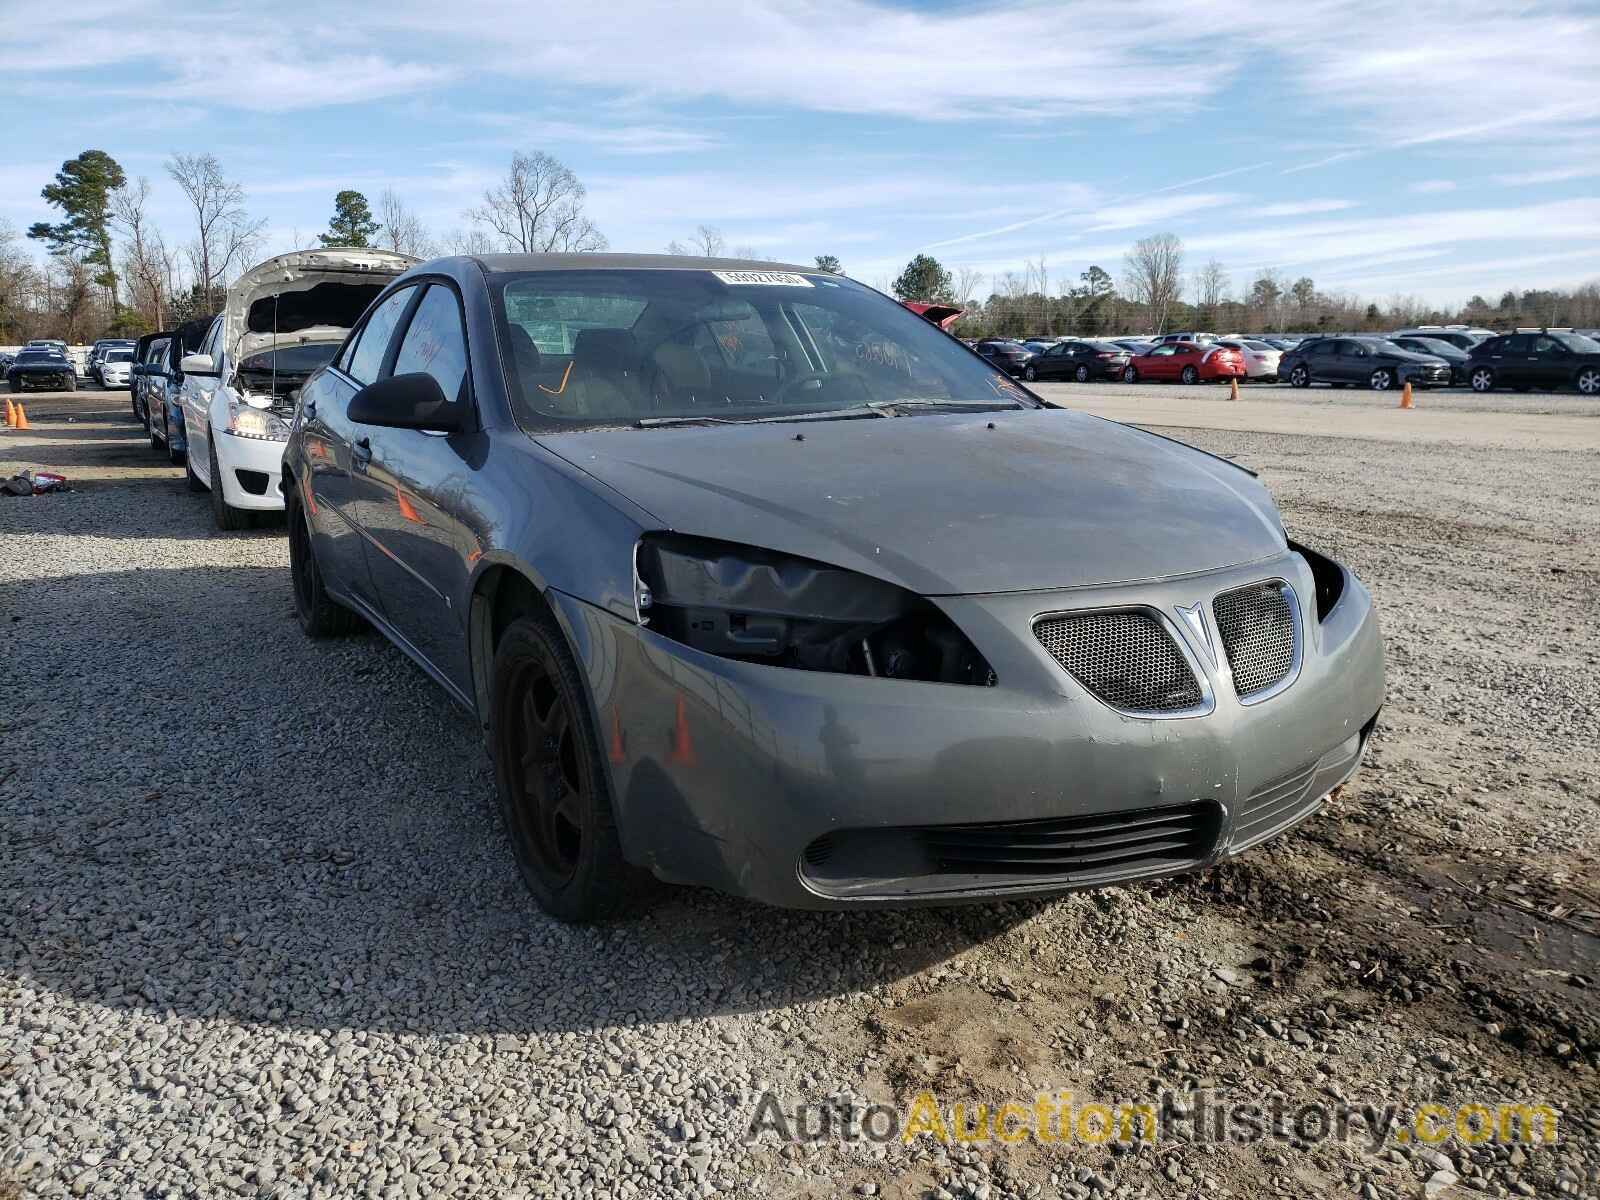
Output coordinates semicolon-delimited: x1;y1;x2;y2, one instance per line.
800;800;1222;898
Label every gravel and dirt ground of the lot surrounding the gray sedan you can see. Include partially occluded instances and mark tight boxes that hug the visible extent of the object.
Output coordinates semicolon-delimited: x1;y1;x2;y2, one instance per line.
0;386;1600;1200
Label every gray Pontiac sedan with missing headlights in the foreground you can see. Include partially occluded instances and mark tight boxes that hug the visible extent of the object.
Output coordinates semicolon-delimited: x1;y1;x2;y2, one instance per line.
283;254;1384;920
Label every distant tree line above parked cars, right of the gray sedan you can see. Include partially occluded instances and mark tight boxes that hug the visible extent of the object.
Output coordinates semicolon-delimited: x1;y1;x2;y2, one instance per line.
888;234;1600;338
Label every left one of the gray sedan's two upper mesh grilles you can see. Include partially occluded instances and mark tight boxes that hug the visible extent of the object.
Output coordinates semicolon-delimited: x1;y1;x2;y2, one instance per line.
1034;610;1203;714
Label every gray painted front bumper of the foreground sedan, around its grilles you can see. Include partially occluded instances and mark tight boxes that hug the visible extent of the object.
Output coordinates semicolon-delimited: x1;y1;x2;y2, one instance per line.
552;555;1384;907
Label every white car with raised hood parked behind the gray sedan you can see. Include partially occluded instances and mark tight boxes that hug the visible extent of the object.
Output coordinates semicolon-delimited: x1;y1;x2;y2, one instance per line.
179;246;419;530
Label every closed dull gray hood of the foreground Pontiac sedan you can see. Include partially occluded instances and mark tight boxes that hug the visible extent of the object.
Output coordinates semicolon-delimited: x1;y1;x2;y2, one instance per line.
538;410;1285;595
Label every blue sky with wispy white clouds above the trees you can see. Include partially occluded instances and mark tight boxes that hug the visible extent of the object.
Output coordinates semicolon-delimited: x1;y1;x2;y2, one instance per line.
0;0;1600;302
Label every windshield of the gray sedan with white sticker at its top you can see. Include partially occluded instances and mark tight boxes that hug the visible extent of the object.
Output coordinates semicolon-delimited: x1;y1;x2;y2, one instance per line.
490;269;1035;430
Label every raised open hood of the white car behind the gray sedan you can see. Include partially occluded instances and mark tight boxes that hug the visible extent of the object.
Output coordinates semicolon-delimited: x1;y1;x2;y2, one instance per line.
222;246;421;363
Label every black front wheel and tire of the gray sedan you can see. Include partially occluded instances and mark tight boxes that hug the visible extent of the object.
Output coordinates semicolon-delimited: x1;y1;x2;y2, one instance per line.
490;614;642;922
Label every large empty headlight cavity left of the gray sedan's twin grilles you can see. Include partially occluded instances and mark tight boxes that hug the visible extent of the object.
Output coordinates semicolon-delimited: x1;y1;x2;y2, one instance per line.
637;534;995;686
